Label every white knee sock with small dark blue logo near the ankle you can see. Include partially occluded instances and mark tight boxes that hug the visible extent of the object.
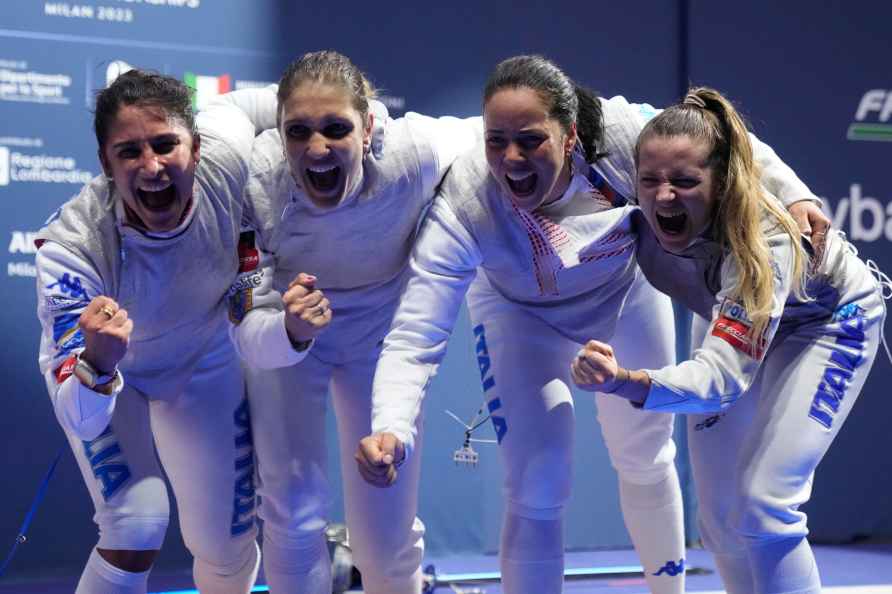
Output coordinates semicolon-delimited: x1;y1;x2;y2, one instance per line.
619;467;685;594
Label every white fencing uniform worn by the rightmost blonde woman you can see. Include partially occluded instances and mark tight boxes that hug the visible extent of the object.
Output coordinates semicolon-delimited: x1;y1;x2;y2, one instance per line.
636;213;885;594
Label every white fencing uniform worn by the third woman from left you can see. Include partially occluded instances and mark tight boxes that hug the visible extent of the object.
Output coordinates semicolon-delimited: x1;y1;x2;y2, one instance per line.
372;97;813;594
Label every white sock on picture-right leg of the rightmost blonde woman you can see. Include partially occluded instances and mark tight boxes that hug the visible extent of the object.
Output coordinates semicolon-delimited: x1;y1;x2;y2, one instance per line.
747;537;821;594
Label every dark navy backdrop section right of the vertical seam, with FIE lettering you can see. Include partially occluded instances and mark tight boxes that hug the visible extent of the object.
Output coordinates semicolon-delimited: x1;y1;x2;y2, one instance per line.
690;0;892;542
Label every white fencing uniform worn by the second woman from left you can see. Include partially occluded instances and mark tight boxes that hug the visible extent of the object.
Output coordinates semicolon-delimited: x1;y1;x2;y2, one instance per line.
231;98;482;594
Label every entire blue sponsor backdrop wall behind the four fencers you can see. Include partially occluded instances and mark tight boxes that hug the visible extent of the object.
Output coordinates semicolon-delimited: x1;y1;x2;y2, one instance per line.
0;0;892;579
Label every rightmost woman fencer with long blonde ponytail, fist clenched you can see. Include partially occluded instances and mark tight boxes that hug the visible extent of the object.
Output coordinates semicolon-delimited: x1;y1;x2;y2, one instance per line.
571;88;888;594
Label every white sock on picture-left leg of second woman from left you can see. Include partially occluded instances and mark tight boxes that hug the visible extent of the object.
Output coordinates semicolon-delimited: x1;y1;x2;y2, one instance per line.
263;530;331;594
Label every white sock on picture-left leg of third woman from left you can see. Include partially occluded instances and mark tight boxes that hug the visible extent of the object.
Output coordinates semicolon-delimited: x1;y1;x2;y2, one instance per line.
500;511;564;594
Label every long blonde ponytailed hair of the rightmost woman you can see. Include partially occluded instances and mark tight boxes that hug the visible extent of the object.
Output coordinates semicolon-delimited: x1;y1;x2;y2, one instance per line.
635;87;808;340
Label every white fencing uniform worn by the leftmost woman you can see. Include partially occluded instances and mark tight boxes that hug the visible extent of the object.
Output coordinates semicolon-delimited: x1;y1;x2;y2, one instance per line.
37;99;259;594
